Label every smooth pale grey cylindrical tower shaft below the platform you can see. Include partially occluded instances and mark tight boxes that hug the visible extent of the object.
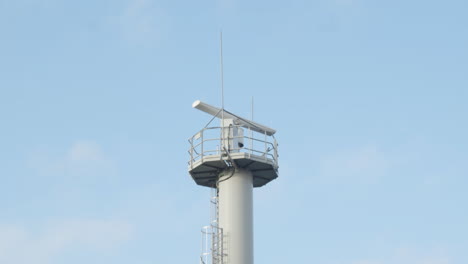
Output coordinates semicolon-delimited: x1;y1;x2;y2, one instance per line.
218;168;254;264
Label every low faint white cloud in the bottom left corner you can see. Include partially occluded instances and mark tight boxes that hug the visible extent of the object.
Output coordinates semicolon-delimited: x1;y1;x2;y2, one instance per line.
0;220;134;264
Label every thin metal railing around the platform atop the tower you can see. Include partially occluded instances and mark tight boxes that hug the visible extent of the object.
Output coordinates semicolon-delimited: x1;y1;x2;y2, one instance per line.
188;125;278;167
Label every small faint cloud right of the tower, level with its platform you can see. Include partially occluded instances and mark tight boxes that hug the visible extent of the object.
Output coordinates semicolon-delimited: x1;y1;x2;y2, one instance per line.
319;146;389;182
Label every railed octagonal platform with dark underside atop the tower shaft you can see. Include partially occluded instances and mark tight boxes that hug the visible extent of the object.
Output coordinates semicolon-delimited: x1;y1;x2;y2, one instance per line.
188;125;278;188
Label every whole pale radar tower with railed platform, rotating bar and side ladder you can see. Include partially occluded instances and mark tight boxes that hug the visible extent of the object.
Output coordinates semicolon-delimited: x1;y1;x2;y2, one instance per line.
188;101;278;264
